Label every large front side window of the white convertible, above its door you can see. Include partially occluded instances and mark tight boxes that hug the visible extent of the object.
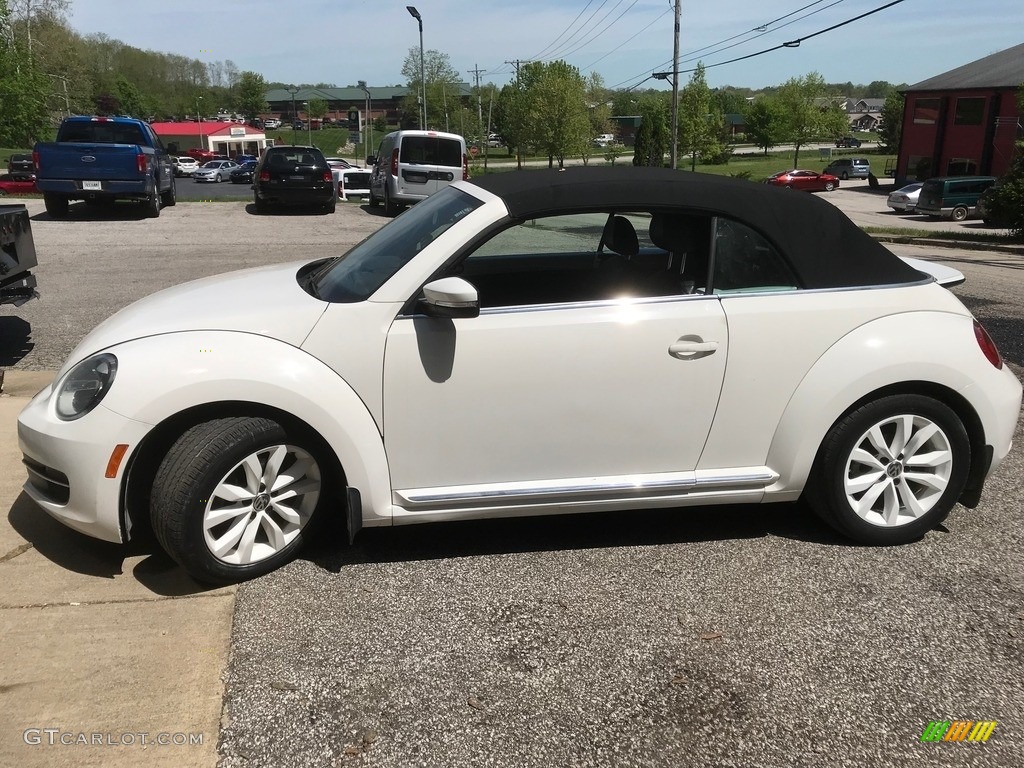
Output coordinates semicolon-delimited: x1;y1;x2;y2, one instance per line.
447;211;710;309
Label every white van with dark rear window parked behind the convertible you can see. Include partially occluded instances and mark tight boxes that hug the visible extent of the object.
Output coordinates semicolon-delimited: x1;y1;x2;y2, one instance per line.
367;131;469;216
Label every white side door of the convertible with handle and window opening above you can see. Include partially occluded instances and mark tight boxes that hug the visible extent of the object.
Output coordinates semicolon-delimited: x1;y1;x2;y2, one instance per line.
384;210;728;506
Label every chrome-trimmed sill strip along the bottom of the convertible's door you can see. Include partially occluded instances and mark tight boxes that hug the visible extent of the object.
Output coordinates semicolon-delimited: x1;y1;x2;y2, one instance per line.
394;467;778;509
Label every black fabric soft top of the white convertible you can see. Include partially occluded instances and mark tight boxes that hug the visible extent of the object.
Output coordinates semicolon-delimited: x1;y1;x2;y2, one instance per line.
473;166;926;288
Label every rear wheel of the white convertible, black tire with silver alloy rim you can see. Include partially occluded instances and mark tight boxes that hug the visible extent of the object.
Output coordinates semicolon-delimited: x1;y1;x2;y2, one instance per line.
807;394;971;546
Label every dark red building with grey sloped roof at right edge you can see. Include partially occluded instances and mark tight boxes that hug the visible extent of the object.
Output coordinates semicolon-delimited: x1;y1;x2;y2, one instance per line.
895;43;1024;186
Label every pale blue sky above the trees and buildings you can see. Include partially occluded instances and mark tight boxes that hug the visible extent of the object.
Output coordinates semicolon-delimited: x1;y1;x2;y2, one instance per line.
70;0;1024;88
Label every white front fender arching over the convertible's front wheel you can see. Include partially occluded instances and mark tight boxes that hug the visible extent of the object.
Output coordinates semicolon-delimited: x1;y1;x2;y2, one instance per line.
103;331;391;526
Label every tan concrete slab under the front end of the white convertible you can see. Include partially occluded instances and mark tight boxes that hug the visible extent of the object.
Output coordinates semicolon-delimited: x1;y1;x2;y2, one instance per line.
0;371;234;768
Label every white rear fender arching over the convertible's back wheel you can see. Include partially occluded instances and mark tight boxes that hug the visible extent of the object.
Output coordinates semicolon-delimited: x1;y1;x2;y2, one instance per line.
767;311;1003;495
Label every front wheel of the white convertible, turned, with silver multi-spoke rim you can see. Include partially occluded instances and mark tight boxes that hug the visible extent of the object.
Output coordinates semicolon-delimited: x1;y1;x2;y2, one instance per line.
150;417;327;584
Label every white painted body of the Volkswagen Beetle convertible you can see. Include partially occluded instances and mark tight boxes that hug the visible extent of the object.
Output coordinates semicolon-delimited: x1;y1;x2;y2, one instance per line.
18;169;1021;581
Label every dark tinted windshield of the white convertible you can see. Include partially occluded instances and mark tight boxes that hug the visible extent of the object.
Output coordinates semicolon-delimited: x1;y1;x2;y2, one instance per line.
311;186;483;302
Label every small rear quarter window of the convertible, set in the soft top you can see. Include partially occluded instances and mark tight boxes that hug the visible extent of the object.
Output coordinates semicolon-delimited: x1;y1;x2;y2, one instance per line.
712;218;800;294
